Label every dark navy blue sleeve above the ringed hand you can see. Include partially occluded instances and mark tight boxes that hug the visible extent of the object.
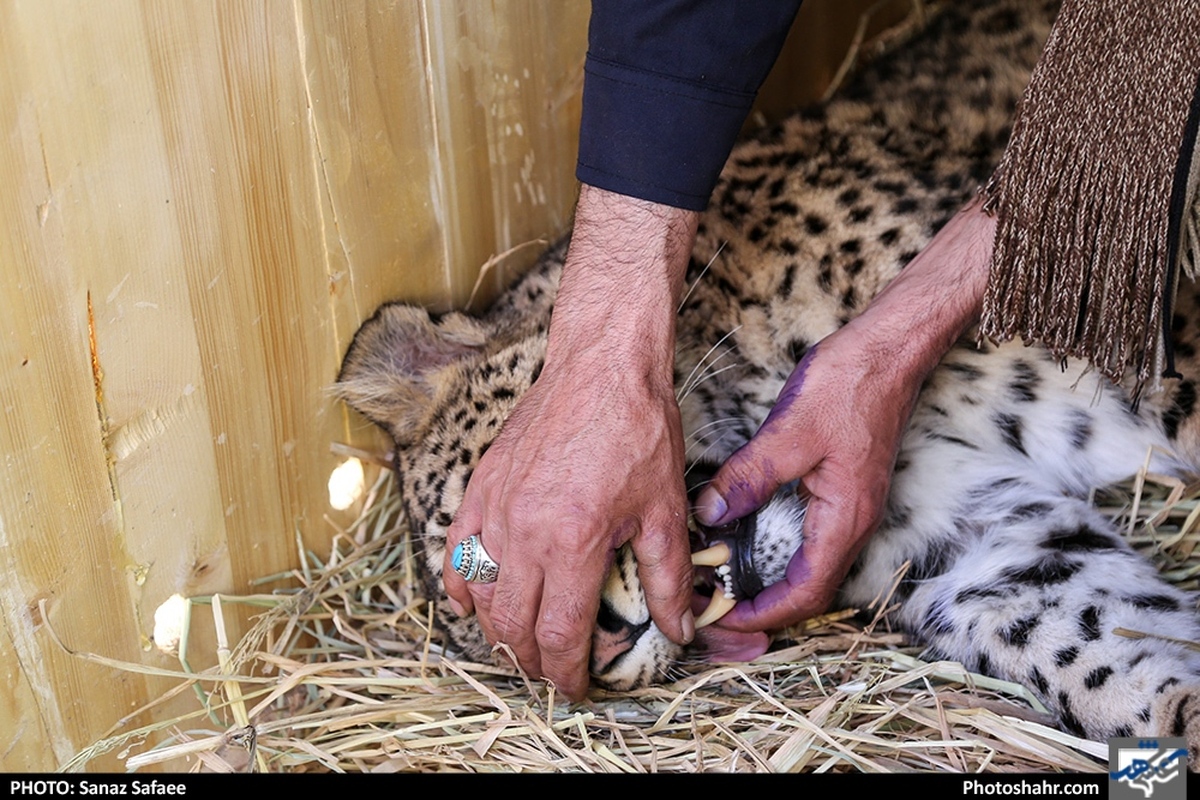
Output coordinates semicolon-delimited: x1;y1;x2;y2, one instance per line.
576;0;800;211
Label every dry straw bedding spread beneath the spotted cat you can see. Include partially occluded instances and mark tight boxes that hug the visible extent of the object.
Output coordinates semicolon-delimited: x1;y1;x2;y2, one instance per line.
65;455;1200;772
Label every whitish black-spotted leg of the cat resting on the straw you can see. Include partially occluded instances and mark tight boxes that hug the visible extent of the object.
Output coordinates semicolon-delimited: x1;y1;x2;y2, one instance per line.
868;494;1200;764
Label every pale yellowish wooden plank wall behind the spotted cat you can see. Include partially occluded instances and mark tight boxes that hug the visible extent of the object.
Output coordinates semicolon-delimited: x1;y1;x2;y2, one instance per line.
0;0;907;771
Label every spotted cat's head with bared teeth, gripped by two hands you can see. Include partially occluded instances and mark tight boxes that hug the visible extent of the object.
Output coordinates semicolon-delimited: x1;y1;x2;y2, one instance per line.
336;267;803;690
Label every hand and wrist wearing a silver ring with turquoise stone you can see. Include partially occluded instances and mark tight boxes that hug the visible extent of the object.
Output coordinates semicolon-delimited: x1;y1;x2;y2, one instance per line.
443;187;697;698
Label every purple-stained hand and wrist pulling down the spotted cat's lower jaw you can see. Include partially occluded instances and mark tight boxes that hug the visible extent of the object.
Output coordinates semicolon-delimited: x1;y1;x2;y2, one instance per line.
697;201;995;631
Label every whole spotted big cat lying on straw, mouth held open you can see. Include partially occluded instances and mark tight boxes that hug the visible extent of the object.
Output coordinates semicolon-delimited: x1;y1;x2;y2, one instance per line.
338;0;1200;763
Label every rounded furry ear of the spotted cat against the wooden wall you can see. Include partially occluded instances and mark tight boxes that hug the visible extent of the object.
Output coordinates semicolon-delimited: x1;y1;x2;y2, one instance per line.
334;303;487;445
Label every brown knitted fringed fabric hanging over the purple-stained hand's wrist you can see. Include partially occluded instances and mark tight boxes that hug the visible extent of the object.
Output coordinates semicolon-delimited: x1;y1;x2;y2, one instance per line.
980;0;1200;386
